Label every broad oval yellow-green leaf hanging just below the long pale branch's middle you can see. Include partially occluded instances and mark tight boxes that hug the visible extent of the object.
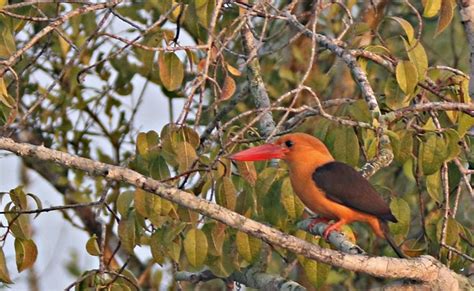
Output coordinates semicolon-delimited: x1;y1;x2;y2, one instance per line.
184;229;208;268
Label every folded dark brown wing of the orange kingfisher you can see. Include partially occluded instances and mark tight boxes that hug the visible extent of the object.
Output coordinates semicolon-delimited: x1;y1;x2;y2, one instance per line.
313;162;397;222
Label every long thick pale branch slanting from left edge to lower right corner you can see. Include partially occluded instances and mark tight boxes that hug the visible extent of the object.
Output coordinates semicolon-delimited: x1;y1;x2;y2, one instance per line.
0;137;468;290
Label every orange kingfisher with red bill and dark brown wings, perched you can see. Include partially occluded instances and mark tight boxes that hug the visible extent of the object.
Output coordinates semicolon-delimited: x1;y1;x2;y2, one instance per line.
230;133;406;258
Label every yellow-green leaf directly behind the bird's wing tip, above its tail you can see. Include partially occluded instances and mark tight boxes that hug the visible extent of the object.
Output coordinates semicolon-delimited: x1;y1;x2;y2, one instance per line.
389;197;411;242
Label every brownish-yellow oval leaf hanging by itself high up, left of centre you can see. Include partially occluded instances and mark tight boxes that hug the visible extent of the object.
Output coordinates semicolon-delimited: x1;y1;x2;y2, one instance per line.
158;52;184;91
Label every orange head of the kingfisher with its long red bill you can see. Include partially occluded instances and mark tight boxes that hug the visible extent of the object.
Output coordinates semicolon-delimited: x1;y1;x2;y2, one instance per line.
230;133;334;167
